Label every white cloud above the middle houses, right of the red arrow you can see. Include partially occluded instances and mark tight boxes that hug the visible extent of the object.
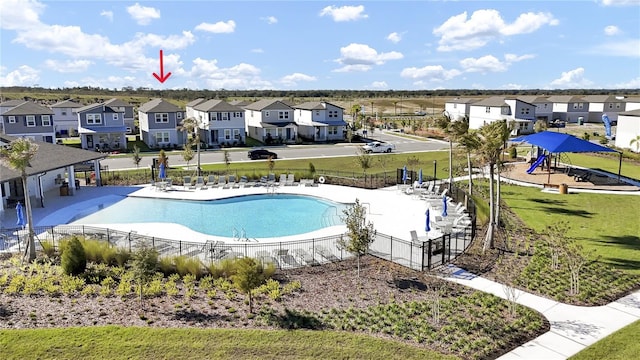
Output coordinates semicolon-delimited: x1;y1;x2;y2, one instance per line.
335;43;404;72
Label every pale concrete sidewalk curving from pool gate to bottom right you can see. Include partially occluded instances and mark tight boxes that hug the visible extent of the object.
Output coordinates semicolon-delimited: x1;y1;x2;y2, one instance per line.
445;265;640;360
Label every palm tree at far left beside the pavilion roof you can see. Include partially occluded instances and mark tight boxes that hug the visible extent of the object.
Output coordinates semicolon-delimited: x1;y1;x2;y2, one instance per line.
0;138;38;262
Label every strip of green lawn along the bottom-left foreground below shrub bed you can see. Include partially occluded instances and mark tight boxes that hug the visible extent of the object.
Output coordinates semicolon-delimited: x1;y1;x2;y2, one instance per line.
0;326;456;360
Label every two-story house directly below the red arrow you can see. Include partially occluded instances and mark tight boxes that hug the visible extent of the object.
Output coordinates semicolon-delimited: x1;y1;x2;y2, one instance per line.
138;99;185;148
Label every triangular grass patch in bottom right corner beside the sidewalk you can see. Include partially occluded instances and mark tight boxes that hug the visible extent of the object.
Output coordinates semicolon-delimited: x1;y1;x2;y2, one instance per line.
569;321;640;360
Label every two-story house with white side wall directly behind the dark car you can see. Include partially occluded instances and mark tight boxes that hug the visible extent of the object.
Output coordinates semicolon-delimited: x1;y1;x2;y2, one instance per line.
244;99;297;145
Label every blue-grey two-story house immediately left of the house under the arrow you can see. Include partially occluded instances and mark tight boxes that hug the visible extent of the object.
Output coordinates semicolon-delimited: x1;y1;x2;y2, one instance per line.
76;103;127;151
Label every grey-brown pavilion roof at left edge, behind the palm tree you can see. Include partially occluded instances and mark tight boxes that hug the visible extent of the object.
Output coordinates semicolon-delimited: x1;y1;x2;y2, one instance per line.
0;134;107;183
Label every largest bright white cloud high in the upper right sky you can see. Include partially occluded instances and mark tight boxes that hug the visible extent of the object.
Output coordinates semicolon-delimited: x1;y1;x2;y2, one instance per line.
433;9;558;51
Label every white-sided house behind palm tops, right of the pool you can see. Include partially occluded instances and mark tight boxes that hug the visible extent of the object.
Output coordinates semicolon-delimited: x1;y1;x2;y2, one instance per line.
469;96;536;134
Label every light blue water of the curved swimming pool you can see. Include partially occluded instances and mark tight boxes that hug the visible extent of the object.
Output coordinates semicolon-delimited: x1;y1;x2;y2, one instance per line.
70;194;347;238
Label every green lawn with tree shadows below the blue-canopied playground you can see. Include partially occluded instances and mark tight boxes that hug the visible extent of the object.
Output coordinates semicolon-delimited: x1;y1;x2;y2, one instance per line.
502;185;640;274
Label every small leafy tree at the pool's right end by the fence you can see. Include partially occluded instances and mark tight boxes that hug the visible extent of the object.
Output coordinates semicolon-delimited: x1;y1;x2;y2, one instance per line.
338;199;375;277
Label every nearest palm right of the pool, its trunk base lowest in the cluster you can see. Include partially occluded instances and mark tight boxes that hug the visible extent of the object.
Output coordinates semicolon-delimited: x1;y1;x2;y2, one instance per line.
478;121;505;251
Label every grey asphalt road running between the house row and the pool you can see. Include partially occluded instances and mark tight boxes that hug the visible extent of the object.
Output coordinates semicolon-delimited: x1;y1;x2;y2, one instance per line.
100;132;448;170
